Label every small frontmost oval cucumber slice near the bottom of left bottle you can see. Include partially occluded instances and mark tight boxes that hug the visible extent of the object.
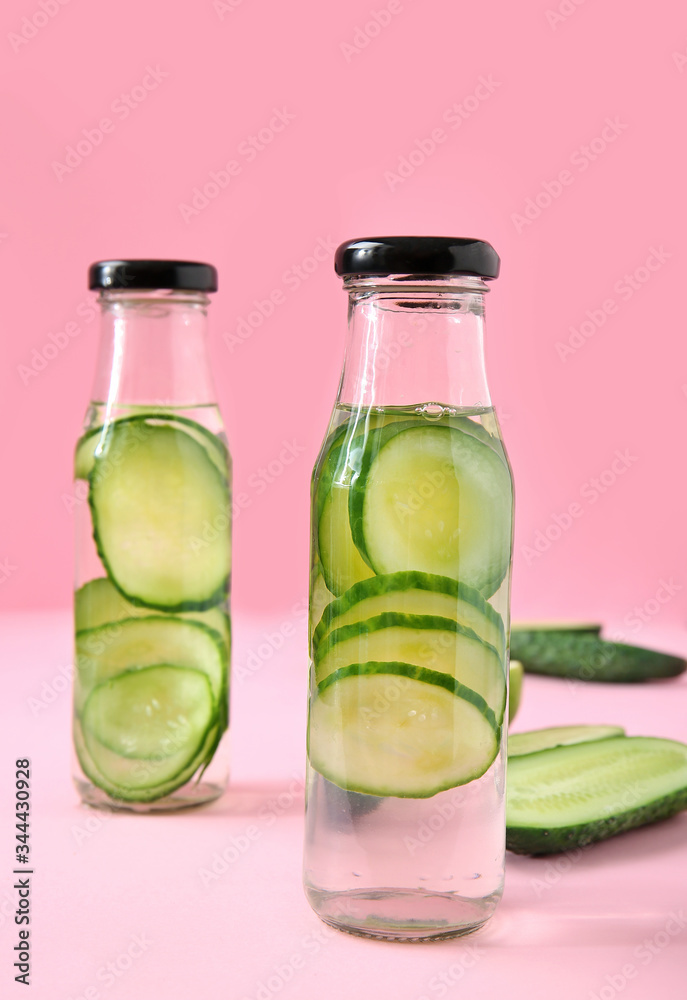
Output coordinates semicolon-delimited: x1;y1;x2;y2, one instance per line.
81;666;214;756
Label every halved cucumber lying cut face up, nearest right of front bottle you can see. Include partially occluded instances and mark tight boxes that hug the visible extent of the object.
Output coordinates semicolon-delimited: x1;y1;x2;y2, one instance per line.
506;736;687;854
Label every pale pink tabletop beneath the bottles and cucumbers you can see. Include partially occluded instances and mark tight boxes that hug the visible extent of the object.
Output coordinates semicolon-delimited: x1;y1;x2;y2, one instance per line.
0;614;687;1000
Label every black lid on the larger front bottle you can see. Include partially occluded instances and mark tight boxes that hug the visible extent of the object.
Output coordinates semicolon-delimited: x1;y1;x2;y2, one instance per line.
334;236;501;278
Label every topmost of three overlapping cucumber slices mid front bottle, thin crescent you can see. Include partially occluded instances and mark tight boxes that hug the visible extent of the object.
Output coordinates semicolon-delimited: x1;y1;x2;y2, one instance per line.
313;572;506;654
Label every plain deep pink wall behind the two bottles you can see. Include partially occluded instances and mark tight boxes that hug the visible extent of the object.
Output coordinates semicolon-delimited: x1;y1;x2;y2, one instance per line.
0;0;687;637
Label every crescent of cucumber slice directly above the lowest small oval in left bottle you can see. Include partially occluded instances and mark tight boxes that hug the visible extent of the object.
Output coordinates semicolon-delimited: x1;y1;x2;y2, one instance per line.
75;615;227;712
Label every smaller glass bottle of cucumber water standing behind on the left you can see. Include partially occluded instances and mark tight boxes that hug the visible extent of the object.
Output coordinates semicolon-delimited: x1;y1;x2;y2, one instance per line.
73;260;231;811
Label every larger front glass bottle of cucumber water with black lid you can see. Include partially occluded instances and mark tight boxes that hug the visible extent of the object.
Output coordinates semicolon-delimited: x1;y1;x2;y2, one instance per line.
304;237;513;940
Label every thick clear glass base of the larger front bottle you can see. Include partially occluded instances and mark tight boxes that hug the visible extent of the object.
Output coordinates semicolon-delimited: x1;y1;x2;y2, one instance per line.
305;886;501;941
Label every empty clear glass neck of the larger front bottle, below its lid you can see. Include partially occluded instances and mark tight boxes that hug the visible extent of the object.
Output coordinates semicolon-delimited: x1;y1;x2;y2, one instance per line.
338;275;491;409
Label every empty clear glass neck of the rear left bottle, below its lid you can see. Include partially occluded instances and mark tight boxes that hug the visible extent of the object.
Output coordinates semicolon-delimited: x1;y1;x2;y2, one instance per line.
93;290;215;410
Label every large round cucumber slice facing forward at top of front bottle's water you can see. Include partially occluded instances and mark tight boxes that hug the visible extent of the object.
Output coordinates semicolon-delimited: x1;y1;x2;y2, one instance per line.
349;421;512;597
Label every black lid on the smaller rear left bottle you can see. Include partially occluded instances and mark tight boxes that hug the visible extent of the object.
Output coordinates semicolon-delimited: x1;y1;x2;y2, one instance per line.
88;260;217;292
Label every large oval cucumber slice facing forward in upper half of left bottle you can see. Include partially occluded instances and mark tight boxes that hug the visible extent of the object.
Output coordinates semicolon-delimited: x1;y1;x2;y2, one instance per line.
89;417;230;611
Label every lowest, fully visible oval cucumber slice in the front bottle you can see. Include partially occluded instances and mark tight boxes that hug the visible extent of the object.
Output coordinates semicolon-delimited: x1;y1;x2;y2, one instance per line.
308;663;499;798
